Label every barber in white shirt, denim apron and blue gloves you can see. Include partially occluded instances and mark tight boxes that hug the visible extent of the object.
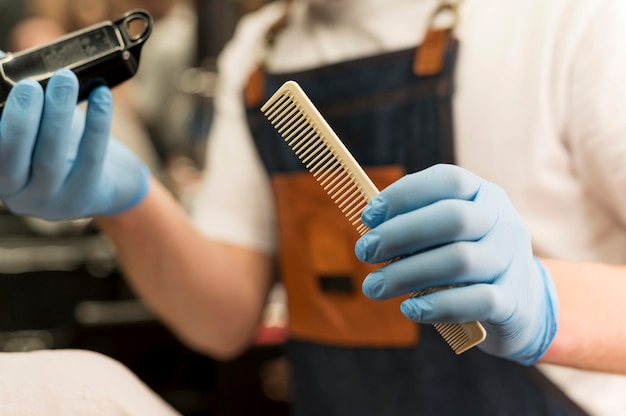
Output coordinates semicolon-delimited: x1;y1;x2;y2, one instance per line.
0;0;626;415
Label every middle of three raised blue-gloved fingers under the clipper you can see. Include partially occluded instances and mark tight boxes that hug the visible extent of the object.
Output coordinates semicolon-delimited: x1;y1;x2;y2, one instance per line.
31;69;78;195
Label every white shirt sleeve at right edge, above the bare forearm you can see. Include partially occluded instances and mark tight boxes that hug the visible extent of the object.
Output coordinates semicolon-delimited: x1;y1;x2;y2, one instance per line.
566;0;626;226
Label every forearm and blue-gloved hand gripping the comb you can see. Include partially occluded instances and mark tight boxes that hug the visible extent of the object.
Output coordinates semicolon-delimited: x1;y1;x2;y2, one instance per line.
355;165;626;374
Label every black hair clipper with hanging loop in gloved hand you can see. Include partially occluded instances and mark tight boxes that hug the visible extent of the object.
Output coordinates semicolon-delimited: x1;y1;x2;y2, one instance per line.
0;10;153;114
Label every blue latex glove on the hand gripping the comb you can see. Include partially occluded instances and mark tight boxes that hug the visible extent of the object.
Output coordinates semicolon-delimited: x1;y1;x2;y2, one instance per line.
355;165;558;365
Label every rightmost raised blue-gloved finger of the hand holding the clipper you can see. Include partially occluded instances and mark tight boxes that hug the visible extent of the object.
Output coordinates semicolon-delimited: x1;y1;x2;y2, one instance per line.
66;86;113;210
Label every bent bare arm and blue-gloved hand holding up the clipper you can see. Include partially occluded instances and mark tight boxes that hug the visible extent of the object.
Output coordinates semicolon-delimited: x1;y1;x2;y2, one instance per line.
0;69;270;358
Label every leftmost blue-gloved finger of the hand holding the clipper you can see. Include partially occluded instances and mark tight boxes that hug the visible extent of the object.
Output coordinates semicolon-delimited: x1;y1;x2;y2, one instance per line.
0;79;44;197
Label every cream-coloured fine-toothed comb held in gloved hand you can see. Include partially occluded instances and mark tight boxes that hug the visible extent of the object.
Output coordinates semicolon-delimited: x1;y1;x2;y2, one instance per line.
261;81;486;354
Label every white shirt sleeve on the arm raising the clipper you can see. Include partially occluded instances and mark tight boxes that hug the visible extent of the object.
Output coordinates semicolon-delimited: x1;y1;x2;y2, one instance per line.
185;5;281;254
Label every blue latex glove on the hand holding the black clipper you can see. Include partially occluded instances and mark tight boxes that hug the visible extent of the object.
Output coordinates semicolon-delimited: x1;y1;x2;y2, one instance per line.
0;69;150;220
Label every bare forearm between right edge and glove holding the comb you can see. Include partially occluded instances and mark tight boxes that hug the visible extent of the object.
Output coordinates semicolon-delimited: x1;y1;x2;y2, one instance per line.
540;259;626;374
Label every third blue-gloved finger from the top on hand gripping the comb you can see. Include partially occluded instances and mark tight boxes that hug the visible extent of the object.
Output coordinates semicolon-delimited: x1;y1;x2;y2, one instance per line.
362;242;506;300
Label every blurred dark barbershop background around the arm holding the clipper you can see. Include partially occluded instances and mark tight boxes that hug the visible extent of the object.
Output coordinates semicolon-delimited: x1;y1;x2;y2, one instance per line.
0;0;289;416
